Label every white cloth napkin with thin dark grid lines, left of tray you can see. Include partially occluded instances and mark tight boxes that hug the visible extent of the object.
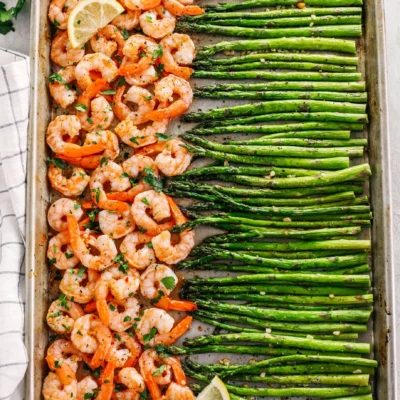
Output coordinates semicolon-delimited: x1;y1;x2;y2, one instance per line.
0;48;29;400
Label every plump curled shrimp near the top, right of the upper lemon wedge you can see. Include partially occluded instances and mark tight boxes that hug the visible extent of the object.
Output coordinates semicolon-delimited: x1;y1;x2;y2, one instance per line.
139;7;176;39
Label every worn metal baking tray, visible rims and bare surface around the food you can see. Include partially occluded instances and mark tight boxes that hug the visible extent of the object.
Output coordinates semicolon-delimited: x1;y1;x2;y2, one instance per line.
25;0;397;400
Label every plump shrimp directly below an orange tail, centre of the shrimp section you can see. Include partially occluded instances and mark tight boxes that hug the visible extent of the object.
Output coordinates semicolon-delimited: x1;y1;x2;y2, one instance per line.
99;209;135;239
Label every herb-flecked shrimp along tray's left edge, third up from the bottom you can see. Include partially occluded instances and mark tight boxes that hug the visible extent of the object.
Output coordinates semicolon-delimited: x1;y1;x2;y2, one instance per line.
46;299;84;335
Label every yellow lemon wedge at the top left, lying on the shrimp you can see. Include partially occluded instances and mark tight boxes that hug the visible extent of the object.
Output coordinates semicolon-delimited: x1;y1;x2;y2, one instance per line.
68;0;125;49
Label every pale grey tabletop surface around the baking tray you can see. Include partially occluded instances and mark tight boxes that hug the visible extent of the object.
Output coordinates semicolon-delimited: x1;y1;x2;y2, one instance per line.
0;0;400;392
